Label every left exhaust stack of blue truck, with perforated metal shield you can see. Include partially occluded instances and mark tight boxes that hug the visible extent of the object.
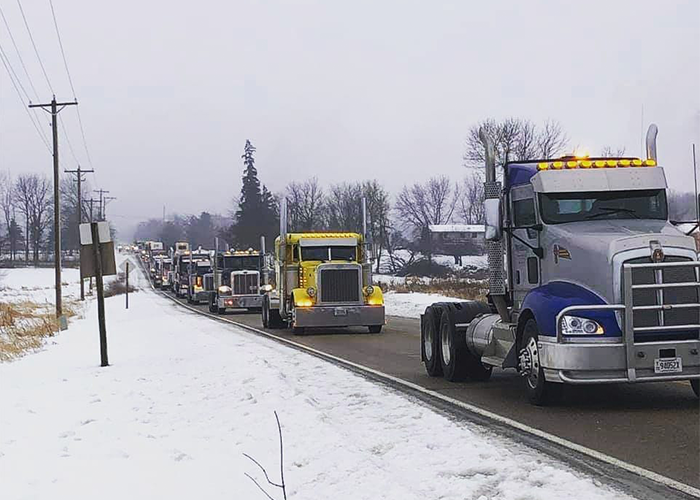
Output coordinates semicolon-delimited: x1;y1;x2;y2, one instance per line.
479;128;510;322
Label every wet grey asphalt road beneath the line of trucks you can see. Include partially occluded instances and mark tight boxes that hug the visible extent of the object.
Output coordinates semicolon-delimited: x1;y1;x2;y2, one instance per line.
165;292;700;488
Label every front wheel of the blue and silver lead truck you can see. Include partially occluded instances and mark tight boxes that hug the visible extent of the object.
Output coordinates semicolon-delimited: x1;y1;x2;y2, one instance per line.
518;319;562;406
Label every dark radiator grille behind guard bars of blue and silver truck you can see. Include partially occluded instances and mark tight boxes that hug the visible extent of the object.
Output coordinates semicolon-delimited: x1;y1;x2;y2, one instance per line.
625;256;700;342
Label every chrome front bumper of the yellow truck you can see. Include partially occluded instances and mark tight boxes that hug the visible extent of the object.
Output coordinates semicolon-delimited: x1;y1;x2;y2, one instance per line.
294;305;385;328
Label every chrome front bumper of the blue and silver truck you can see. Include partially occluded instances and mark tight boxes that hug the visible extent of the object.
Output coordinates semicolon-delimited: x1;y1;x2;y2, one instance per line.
538;338;700;384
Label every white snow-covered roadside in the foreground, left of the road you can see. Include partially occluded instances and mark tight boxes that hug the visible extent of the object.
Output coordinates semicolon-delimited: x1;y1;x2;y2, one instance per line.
0;266;628;500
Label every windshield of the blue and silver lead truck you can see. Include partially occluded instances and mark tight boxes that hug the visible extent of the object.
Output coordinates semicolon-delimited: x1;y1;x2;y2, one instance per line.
540;189;668;224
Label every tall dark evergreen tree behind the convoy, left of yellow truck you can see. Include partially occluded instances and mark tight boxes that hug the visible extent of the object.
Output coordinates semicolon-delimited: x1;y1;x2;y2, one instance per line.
230;140;279;249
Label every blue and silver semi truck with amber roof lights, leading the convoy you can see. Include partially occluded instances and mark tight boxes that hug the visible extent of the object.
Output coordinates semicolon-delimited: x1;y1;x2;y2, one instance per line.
422;125;700;405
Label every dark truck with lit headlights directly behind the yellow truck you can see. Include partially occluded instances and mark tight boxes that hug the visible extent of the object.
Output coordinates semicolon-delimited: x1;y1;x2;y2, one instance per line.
204;249;265;314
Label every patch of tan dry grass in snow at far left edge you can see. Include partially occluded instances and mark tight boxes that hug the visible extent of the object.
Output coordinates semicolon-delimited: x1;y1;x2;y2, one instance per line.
0;301;78;362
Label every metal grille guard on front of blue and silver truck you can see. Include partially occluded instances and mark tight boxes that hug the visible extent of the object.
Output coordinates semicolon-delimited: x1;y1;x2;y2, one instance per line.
623;256;700;342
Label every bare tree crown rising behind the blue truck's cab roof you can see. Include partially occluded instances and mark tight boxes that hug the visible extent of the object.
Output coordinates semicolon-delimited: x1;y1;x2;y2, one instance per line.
463;118;568;174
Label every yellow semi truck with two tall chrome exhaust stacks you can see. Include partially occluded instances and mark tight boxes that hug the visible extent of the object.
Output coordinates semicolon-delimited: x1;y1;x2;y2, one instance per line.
262;200;384;334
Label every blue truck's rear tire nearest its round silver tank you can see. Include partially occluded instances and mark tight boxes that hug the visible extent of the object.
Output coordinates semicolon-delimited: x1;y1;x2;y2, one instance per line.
439;301;492;382
